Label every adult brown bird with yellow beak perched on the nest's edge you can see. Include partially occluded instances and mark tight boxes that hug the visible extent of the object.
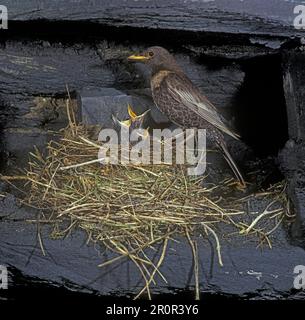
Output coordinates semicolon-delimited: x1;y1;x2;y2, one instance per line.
128;47;245;186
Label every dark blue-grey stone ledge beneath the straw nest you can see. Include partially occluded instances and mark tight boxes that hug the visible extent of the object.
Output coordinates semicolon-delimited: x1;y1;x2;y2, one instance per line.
0;195;305;299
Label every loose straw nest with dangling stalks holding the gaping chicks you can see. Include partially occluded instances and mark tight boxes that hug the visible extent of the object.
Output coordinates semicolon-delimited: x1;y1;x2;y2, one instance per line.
22;102;289;298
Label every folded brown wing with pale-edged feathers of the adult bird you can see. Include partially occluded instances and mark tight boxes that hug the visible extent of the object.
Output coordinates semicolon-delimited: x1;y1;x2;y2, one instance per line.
163;72;239;139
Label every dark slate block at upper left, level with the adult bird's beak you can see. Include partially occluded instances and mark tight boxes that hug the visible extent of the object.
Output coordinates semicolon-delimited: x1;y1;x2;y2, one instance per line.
0;41;115;98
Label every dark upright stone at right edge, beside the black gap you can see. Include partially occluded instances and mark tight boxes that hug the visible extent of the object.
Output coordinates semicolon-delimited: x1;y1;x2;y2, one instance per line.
279;48;305;246
